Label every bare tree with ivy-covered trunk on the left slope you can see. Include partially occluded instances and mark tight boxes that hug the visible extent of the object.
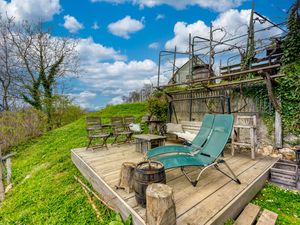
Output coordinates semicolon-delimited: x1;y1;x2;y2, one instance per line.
8;21;78;129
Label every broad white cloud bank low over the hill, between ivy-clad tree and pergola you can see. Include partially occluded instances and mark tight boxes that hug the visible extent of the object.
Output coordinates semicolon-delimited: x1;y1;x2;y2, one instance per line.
71;38;157;106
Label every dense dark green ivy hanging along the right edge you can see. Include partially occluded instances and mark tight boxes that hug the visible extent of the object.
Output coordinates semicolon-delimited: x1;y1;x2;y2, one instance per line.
275;0;300;135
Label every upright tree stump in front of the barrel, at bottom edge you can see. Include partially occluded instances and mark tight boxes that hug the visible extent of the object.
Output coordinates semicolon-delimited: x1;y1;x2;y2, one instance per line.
146;183;176;225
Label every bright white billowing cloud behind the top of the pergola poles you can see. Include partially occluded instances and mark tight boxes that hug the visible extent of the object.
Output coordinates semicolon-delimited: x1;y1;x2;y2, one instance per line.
165;9;281;51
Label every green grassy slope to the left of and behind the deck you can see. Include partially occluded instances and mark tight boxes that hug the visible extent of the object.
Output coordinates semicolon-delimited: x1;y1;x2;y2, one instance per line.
0;103;146;224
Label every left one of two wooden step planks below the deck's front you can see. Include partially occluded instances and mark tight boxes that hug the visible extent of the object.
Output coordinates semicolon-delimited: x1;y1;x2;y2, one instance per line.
234;203;260;225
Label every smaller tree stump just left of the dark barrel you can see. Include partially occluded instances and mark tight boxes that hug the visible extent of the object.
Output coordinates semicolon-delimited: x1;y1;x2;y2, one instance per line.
117;162;136;193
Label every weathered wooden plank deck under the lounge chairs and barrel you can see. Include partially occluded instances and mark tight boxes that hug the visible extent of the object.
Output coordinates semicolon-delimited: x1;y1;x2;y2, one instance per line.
71;144;277;225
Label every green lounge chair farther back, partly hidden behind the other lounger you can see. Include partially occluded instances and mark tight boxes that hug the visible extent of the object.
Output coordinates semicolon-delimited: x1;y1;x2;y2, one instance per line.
147;114;215;158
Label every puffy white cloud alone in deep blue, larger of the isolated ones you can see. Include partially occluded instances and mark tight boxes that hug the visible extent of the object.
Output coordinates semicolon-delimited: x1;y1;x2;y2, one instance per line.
108;16;144;39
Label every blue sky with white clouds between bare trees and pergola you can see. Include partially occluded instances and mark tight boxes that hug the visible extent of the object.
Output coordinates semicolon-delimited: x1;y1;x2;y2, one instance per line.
0;0;293;110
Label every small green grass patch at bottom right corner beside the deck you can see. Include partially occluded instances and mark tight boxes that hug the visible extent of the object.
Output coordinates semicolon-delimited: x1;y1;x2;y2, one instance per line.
252;183;300;225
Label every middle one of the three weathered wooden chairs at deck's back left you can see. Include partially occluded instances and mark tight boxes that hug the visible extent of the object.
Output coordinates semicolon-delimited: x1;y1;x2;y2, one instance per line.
111;116;133;145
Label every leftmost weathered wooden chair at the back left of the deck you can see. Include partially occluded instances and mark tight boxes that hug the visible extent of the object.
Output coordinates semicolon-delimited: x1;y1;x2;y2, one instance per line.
86;116;111;149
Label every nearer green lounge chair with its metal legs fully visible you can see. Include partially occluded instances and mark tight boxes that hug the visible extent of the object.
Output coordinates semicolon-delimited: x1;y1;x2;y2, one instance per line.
152;114;241;186
